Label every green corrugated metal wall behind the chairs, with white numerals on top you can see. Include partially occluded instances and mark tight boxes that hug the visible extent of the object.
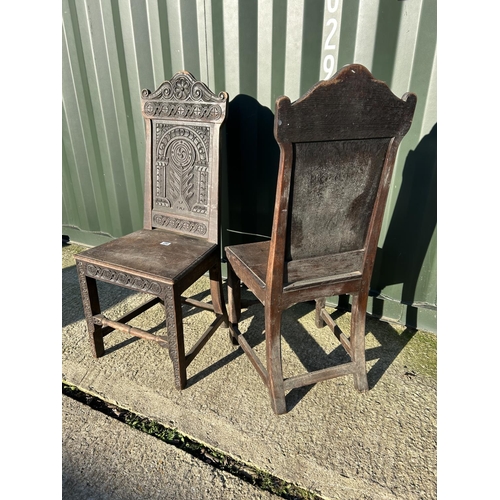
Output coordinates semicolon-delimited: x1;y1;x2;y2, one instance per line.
62;0;437;331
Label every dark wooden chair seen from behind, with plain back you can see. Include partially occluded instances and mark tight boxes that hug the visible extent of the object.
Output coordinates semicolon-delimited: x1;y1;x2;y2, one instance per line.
225;64;416;414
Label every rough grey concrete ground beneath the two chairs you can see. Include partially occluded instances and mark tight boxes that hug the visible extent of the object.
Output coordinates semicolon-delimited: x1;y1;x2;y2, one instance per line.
62;240;437;500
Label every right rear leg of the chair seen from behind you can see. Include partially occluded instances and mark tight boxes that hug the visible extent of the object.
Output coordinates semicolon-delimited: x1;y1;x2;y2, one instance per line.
350;292;369;392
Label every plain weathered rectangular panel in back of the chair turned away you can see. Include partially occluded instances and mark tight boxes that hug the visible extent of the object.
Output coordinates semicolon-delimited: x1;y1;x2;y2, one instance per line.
285;138;390;260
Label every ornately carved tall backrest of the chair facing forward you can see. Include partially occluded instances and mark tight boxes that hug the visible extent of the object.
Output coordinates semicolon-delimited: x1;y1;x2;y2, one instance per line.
141;71;228;243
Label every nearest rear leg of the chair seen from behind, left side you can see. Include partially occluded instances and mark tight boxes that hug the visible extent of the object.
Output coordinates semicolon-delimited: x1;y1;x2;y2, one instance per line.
265;306;287;415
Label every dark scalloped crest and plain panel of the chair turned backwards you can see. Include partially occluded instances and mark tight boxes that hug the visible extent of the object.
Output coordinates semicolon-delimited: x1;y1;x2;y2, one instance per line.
275;65;416;270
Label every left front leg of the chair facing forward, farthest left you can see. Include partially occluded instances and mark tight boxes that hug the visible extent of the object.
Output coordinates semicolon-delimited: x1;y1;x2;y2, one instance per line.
77;261;104;358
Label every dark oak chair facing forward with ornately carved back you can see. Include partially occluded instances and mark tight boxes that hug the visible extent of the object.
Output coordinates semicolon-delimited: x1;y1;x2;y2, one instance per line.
75;71;228;389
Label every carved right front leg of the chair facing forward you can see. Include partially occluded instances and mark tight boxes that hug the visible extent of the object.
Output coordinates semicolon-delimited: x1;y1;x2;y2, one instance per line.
163;286;187;390
